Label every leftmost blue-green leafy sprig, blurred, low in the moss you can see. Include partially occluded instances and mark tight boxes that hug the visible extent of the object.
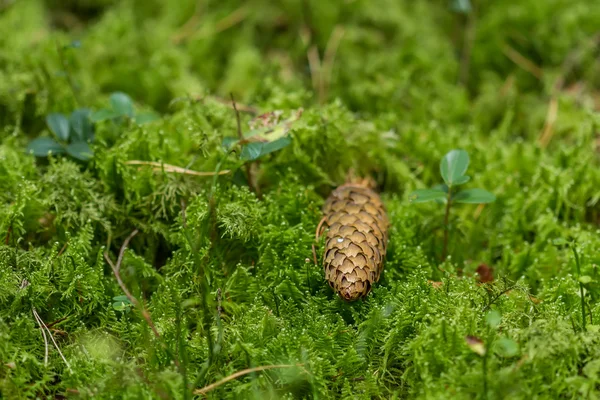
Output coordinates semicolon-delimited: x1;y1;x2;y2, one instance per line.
27;108;94;161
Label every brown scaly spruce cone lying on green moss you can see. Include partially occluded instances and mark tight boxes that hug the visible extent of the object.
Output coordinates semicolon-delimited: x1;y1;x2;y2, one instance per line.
323;182;388;301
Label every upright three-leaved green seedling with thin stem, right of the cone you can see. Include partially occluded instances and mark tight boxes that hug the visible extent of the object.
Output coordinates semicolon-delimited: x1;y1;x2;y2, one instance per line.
410;150;496;260
